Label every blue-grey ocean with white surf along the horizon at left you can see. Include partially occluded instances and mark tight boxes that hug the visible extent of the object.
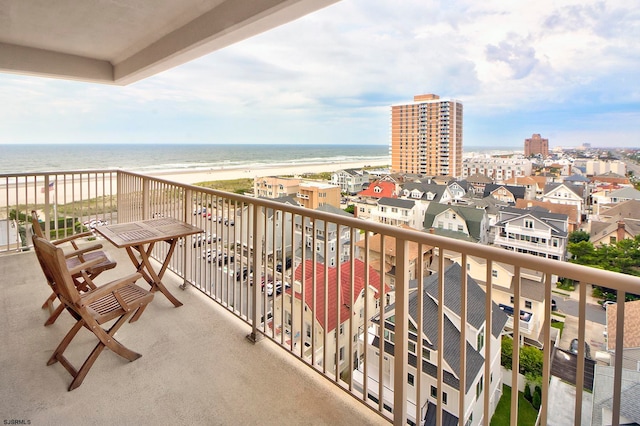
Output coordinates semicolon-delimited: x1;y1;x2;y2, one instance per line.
0;144;391;174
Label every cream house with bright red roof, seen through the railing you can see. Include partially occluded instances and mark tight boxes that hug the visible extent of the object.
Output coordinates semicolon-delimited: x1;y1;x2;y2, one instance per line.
271;259;384;373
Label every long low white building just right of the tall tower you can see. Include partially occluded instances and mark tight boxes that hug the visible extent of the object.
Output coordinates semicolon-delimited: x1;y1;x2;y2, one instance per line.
462;156;533;182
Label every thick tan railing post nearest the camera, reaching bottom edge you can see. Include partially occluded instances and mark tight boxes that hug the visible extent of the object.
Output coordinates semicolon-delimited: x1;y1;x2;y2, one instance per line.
392;238;408;426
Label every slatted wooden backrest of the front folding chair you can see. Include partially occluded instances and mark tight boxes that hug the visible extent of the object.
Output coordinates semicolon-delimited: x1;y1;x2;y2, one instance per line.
33;235;80;305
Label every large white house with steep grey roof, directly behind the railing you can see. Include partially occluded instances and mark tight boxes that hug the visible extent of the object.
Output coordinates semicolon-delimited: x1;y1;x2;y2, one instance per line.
352;264;508;425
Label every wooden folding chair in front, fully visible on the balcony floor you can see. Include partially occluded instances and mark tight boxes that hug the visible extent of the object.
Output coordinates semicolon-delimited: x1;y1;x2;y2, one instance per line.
33;236;153;391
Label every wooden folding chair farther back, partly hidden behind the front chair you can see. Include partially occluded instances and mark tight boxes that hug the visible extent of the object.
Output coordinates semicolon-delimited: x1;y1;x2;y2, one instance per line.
31;210;116;326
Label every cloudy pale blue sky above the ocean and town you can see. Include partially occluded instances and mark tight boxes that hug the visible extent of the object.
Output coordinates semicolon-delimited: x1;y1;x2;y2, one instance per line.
0;0;640;147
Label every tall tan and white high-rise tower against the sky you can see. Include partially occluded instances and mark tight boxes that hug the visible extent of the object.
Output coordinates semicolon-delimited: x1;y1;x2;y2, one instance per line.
391;94;463;177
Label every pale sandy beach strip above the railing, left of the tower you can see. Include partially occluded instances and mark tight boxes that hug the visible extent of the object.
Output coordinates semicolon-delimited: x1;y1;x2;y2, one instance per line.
147;160;389;185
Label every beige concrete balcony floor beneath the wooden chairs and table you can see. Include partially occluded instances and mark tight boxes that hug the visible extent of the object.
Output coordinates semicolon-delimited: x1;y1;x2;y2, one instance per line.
0;242;388;425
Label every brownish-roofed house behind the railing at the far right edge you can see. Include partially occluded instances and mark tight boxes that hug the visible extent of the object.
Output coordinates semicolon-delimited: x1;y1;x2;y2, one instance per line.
607;300;640;372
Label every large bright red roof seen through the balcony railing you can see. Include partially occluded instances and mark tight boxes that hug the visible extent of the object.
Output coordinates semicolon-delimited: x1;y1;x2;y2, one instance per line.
295;259;389;332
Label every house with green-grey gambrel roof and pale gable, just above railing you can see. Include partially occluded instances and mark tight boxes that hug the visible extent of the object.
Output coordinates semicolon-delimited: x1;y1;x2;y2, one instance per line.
424;203;489;244
